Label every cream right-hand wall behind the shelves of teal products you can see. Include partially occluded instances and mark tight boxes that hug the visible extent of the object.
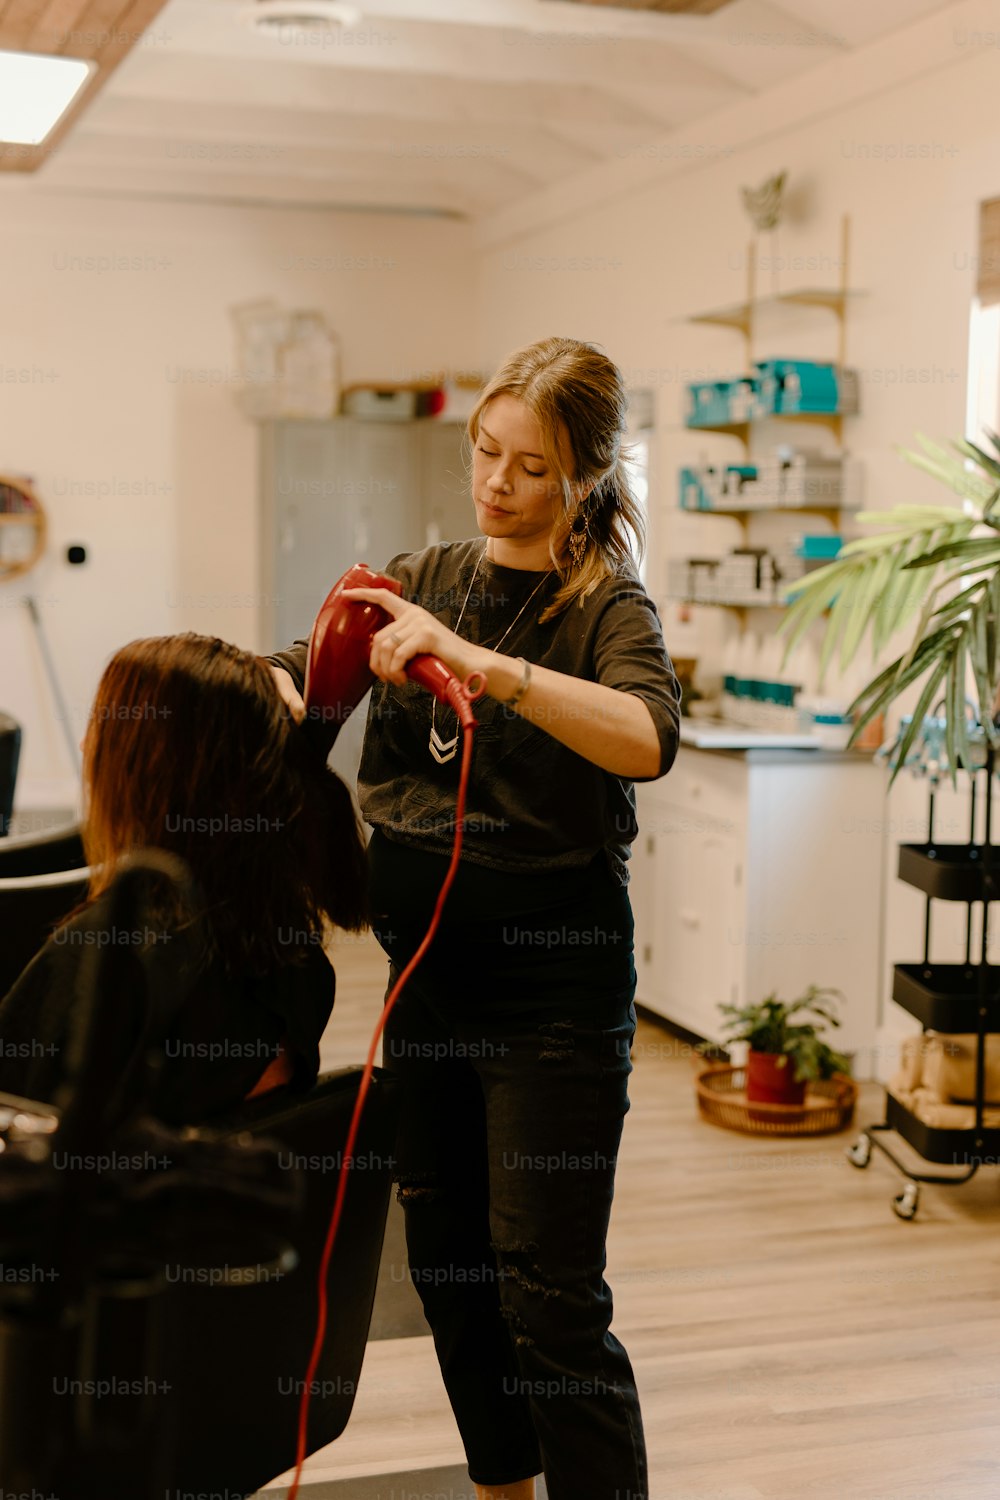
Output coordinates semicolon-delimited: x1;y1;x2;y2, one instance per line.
481;0;1000;1077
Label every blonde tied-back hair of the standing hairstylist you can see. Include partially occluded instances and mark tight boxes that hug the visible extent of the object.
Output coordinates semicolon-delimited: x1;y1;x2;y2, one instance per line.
468;339;646;621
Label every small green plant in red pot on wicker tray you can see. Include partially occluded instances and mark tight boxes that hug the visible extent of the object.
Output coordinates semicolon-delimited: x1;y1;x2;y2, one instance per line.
720;984;850;1106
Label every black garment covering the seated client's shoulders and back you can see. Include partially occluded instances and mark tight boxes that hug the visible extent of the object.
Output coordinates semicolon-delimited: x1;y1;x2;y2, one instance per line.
0;909;336;1125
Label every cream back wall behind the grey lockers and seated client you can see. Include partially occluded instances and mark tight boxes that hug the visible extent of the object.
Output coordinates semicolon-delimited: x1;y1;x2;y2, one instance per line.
0;193;475;807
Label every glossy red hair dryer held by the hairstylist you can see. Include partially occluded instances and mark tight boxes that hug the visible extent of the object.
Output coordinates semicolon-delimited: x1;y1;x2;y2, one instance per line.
304;563;486;755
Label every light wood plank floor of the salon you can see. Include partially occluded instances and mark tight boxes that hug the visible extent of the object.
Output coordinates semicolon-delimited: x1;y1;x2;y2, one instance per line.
269;939;1000;1500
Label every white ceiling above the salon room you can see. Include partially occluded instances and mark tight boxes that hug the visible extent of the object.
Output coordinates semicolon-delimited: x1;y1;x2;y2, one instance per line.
21;0;949;219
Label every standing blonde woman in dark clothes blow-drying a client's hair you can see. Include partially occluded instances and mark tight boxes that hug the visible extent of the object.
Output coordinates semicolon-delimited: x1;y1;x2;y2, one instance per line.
271;339;679;1500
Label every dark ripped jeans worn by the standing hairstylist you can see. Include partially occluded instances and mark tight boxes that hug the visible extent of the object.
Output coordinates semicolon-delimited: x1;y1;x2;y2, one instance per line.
369;830;646;1500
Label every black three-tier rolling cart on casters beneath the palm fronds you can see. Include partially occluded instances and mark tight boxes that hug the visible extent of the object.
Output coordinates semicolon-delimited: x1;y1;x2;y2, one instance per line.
847;749;1000;1220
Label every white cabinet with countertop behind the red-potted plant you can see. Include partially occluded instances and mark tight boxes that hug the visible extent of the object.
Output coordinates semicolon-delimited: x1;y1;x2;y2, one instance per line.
630;747;888;1076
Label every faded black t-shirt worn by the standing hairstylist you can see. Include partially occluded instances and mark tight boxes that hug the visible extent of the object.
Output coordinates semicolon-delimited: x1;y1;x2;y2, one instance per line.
268;537;681;885
